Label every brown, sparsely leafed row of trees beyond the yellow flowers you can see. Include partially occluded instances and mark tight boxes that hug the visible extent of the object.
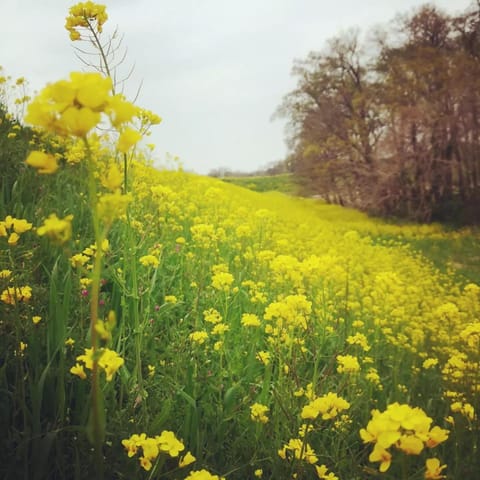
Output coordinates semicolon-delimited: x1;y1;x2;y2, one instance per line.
276;0;480;222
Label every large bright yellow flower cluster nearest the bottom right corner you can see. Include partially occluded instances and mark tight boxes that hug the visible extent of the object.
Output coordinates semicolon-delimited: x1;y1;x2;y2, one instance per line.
360;403;449;472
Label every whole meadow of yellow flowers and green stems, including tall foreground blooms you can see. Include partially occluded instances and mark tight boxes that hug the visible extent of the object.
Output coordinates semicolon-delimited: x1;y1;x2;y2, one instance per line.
0;2;480;480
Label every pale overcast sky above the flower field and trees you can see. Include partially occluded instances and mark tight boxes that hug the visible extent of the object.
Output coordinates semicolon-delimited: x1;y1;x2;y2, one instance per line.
0;0;471;174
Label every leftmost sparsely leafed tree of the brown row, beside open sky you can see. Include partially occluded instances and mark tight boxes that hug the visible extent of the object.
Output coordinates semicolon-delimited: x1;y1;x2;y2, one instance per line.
277;31;382;206
